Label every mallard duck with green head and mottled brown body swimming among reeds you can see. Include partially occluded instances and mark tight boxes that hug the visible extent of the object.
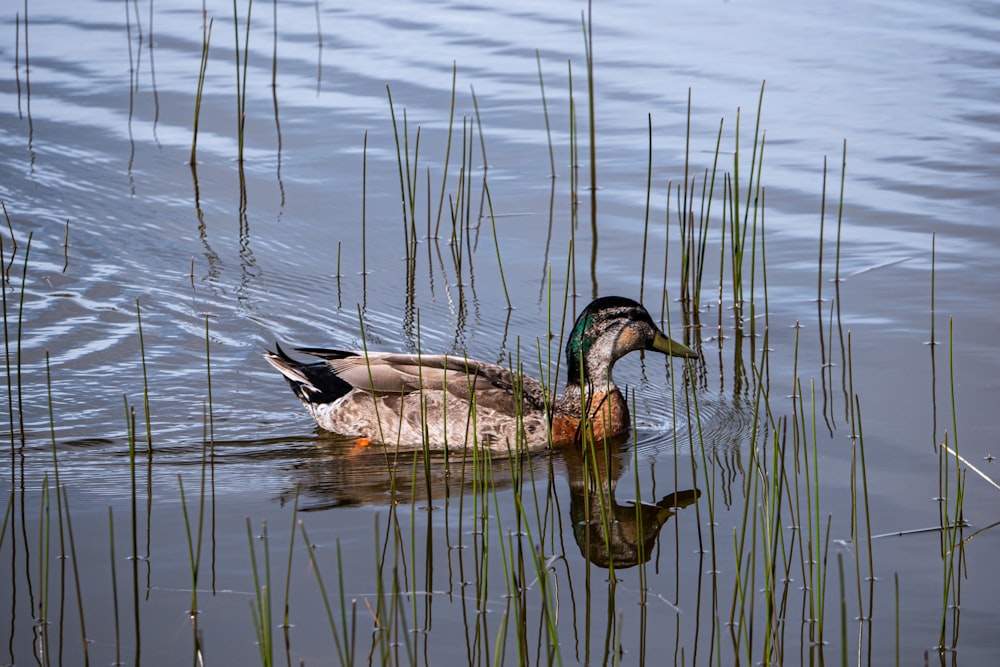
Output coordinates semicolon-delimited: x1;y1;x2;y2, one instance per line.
264;296;697;450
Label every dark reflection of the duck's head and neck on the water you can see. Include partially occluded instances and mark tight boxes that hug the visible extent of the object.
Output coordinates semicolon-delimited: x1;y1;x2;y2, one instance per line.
562;442;701;568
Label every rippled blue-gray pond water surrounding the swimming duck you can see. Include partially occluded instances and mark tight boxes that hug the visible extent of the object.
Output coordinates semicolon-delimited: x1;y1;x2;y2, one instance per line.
0;0;1000;665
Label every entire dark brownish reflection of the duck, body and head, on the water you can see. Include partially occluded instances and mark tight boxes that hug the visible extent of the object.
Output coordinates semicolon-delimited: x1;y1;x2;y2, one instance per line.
272;437;701;568
